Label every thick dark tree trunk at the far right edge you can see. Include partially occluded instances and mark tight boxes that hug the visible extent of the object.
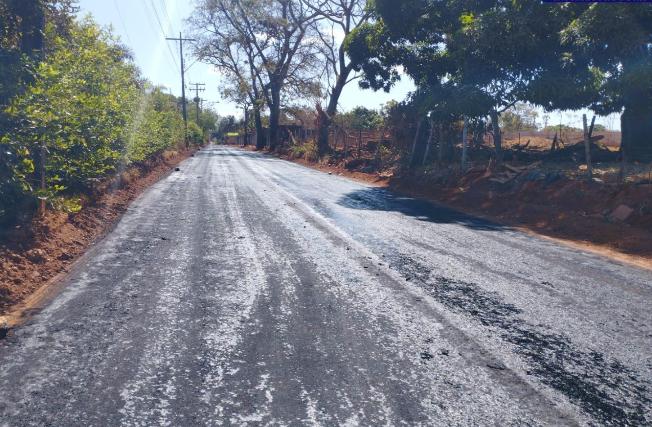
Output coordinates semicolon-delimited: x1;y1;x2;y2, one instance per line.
620;103;652;161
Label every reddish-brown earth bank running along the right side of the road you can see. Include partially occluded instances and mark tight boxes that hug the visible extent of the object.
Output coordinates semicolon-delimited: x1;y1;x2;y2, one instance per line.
252;144;652;269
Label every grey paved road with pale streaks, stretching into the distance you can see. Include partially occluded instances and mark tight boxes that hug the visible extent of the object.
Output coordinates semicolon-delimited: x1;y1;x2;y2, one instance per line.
0;147;652;426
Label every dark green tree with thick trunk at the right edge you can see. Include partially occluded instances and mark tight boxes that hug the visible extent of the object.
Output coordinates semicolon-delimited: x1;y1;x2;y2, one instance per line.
562;3;652;160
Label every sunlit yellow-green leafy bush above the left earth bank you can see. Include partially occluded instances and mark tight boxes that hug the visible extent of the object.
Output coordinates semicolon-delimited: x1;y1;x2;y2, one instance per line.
0;19;194;222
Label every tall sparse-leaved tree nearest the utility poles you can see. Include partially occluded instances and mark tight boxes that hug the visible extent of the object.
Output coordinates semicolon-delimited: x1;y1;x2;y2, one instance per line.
188;0;318;149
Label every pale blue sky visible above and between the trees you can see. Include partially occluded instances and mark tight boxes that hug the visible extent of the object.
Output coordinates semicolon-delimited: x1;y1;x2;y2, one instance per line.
79;0;620;130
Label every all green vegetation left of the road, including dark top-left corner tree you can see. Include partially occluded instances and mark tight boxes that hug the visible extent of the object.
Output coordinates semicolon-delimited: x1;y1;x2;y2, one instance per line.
0;0;217;225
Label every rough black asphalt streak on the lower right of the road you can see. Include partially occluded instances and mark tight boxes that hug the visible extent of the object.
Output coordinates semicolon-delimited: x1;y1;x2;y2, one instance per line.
386;253;652;426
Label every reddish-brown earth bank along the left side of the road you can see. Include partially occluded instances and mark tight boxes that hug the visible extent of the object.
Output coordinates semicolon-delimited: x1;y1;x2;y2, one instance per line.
0;150;199;320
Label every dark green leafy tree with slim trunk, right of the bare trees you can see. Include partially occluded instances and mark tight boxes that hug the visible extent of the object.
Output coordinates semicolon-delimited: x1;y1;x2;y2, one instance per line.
348;0;588;162
